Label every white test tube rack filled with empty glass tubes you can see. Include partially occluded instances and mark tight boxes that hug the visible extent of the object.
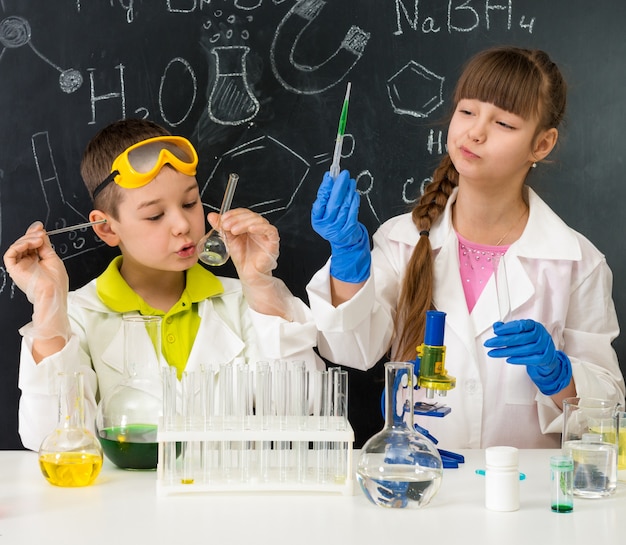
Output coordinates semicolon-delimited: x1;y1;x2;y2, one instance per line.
157;366;354;496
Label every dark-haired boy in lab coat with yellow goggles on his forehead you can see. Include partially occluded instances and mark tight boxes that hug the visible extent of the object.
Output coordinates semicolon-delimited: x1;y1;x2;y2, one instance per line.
4;119;323;450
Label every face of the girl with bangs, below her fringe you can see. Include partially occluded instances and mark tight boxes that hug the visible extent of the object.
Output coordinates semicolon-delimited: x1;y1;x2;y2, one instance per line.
448;99;544;187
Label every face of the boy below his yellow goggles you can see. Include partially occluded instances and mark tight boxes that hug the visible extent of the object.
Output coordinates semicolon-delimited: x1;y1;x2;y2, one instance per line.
110;166;205;271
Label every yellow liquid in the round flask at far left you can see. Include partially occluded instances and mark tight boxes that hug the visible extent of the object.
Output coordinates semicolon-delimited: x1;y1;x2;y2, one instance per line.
39;452;102;486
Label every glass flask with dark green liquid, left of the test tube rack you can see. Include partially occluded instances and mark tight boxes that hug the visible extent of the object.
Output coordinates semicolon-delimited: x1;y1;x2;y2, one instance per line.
96;315;163;469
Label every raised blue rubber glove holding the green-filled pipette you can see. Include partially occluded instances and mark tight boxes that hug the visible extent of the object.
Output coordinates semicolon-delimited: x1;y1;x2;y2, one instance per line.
311;170;372;284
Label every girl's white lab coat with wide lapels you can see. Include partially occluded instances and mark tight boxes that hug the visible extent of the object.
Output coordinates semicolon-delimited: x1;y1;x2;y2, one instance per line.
307;188;624;448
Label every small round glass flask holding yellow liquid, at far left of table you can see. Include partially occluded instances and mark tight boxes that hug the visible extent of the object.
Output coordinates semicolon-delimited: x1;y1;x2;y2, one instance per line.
39;373;102;487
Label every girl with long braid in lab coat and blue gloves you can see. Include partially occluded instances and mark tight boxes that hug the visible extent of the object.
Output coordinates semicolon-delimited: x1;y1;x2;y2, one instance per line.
307;47;624;448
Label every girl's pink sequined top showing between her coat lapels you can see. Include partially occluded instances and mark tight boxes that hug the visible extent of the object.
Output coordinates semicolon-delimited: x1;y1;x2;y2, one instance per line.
456;233;509;313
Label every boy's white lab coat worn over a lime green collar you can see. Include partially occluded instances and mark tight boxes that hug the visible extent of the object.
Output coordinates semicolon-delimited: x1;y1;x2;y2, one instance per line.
19;278;324;450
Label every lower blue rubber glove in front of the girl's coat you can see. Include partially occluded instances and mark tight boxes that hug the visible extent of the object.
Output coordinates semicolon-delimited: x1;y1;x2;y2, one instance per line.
485;320;572;395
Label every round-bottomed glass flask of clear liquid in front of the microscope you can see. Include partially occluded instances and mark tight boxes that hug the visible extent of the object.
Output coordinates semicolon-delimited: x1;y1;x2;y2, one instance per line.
356;362;443;508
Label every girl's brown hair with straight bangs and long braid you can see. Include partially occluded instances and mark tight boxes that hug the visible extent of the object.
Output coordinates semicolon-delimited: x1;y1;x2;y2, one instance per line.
391;47;567;361
